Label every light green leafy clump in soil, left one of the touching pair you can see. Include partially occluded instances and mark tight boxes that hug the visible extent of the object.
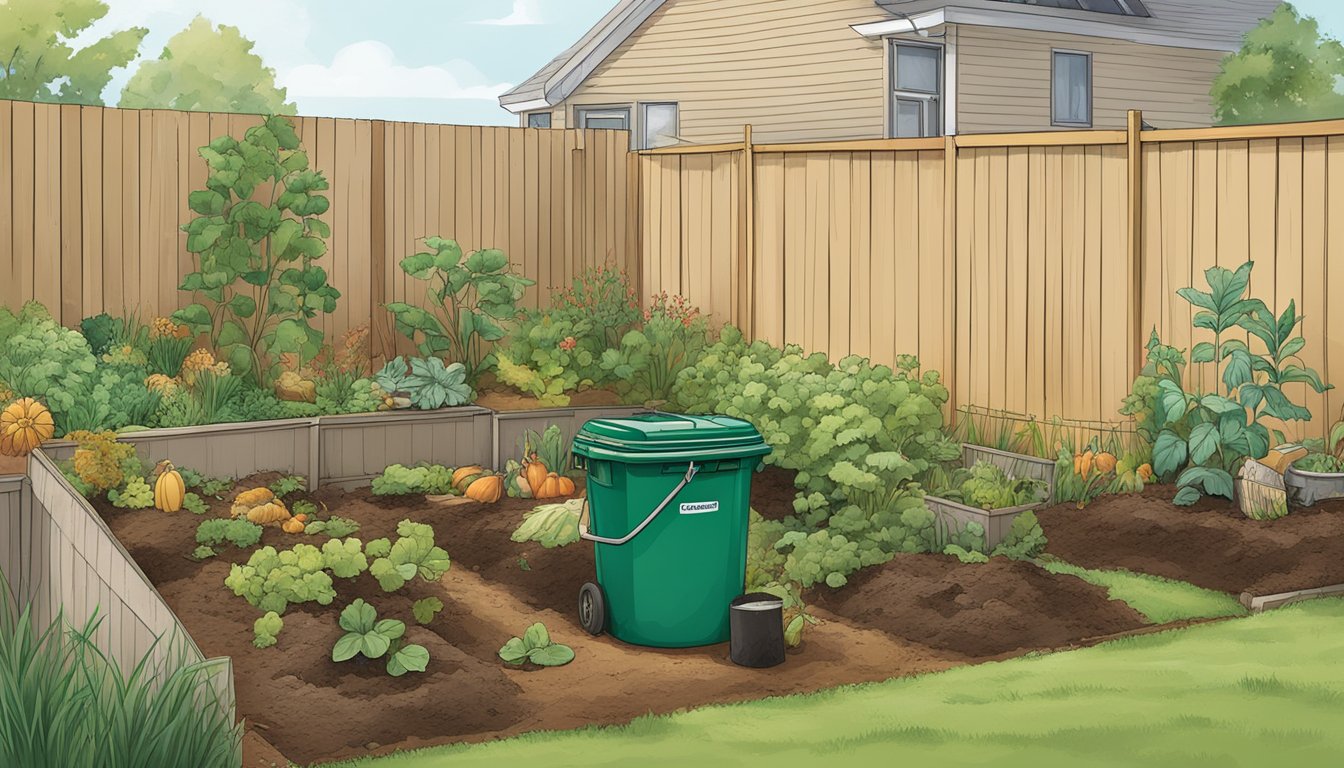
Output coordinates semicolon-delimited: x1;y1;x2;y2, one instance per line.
224;539;368;615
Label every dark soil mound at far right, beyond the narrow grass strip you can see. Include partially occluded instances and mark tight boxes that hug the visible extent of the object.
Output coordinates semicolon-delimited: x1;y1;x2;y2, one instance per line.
1036;486;1344;596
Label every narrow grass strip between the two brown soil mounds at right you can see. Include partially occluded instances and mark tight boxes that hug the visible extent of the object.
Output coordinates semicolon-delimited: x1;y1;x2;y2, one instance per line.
1040;560;1246;624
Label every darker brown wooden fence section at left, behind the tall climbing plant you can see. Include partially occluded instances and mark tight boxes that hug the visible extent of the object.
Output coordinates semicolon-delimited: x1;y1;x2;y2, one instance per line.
0;101;638;355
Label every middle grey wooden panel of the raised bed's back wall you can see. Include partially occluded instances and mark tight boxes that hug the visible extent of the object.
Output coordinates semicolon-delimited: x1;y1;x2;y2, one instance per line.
317;405;493;488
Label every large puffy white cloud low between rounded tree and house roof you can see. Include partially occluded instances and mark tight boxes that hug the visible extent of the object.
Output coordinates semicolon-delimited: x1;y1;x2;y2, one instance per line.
278;40;513;101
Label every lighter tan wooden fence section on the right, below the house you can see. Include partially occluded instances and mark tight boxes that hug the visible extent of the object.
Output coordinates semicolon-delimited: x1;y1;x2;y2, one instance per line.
638;112;1344;434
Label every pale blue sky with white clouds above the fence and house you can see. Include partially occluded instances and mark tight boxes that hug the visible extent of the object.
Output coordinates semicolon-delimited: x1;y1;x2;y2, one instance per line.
77;0;1344;125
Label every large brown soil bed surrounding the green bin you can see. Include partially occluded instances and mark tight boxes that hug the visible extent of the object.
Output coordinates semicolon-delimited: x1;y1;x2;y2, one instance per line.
95;472;1166;764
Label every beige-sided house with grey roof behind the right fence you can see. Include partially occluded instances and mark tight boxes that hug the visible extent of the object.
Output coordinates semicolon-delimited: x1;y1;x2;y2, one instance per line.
500;0;1279;148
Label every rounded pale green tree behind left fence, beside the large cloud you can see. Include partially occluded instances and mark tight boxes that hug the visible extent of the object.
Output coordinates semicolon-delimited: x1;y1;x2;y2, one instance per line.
120;16;296;114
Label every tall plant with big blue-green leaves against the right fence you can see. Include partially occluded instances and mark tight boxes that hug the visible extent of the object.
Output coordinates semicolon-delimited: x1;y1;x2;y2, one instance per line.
1153;262;1331;506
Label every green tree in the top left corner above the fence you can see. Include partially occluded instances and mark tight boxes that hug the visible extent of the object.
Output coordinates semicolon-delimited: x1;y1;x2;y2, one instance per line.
0;0;148;105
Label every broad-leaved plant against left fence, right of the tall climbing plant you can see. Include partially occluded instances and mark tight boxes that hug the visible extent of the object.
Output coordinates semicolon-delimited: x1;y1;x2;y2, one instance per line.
387;237;535;383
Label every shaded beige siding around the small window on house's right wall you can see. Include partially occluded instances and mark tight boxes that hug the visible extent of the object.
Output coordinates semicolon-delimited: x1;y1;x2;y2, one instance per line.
957;24;1224;133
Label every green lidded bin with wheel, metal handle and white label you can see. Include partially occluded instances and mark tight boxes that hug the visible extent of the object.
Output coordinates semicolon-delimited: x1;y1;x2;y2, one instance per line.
573;413;770;648
